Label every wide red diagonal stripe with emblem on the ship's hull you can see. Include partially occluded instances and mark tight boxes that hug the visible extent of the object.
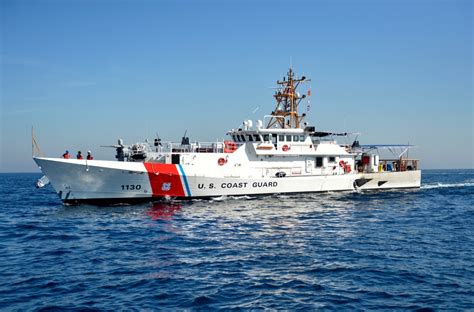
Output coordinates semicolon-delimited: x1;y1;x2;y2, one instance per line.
144;162;185;197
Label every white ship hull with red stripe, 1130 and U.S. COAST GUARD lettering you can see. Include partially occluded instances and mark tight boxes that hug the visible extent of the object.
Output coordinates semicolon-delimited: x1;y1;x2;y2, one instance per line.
34;157;421;204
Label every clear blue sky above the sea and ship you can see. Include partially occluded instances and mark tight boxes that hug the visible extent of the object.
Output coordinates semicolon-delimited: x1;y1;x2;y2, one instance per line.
0;0;474;172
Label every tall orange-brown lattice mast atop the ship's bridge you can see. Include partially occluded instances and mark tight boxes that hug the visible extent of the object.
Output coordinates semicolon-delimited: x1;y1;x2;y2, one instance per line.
267;67;309;129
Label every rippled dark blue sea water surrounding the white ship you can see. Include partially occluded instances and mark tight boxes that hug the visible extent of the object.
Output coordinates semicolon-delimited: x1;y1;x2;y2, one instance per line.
0;170;474;311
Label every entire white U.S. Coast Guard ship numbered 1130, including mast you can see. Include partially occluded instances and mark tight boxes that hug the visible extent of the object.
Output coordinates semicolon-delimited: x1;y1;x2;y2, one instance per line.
33;67;421;204
